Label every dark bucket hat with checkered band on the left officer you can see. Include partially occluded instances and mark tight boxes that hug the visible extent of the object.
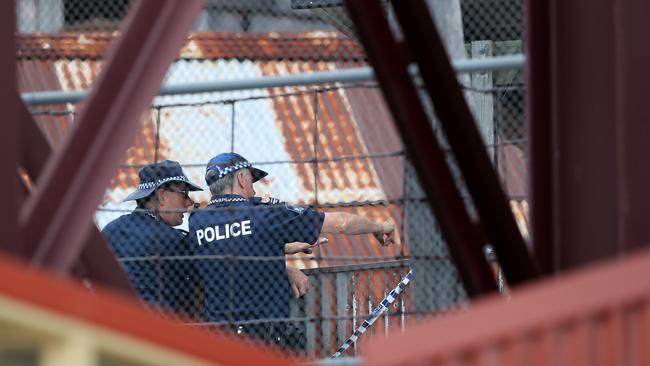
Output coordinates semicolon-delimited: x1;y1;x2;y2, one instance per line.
124;160;203;201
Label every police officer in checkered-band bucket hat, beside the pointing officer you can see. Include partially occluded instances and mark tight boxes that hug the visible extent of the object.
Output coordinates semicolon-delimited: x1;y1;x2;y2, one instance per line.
102;160;202;316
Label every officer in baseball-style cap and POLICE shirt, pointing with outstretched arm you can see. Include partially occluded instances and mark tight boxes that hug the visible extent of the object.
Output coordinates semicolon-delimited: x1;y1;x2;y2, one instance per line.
189;153;394;349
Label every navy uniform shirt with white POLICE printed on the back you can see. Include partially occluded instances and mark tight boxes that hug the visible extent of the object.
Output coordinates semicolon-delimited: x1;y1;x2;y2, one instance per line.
189;194;325;346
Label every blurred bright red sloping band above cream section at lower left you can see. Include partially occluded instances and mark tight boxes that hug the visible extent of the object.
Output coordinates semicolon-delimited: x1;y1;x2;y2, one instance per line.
0;256;297;366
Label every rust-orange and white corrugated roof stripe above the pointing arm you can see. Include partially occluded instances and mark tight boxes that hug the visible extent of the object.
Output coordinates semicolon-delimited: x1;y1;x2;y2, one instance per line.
261;62;385;203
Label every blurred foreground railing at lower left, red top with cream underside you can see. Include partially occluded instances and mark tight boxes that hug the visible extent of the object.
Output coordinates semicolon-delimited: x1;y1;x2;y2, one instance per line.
0;255;293;366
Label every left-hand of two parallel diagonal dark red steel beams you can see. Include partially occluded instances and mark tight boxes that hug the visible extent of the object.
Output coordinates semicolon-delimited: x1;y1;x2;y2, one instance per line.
346;0;496;296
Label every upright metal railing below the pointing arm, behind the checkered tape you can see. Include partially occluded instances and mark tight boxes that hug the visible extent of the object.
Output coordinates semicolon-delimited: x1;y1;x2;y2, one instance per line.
291;260;412;357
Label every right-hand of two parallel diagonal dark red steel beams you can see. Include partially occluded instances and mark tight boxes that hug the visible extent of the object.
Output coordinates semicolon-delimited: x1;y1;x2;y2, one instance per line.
393;0;539;285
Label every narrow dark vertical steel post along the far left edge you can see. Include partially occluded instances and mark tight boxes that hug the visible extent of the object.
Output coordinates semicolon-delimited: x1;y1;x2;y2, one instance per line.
0;1;22;251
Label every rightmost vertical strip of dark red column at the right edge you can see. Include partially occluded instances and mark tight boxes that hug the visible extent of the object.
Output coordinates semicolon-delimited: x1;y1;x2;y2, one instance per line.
614;0;650;251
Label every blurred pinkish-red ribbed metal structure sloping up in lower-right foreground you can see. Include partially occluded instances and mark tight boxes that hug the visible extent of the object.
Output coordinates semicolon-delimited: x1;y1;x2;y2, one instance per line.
362;250;650;366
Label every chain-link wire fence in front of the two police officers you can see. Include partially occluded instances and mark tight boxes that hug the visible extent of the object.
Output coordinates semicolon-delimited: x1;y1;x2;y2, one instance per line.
17;0;527;357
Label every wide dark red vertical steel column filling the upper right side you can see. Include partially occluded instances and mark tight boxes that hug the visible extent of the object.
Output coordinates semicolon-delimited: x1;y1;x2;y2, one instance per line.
525;0;650;272
